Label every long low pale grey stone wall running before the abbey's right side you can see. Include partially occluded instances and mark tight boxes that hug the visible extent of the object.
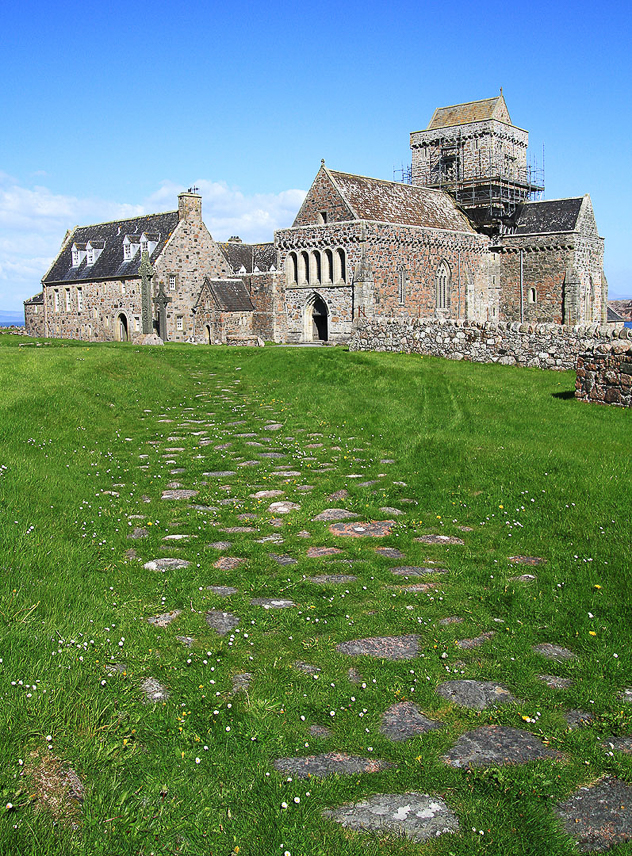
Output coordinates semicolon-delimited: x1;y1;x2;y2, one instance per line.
349;318;632;371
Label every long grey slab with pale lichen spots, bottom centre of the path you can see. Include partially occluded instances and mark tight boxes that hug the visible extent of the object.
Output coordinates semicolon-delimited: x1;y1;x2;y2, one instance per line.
323;792;459;841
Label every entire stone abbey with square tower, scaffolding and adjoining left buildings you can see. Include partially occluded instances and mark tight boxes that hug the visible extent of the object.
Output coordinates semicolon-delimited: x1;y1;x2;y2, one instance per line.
24;93;608;344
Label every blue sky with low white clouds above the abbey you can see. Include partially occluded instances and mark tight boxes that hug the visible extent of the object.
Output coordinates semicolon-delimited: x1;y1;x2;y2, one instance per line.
0;0;632;310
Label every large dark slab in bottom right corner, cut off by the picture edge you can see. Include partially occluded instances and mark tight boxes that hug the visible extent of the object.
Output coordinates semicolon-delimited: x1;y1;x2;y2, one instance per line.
555;776;632;853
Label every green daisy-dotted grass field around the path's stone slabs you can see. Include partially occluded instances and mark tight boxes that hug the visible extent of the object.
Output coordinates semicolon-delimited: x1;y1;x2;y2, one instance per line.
0;336;632;856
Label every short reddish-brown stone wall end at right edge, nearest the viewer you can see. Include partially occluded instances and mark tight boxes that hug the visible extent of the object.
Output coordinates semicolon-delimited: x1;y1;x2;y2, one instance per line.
575;340;632;407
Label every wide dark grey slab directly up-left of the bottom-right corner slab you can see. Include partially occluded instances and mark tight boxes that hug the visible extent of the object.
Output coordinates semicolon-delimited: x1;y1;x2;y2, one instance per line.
443;725;561;767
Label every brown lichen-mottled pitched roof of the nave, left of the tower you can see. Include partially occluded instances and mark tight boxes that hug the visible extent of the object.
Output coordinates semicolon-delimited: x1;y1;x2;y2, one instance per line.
328;170;474;232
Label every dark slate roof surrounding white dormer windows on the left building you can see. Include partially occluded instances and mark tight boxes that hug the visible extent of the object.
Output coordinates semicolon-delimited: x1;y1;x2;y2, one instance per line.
42;211;178;285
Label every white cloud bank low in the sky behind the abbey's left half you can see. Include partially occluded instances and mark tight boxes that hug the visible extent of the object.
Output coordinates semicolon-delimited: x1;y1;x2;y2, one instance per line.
0;172;305;310
